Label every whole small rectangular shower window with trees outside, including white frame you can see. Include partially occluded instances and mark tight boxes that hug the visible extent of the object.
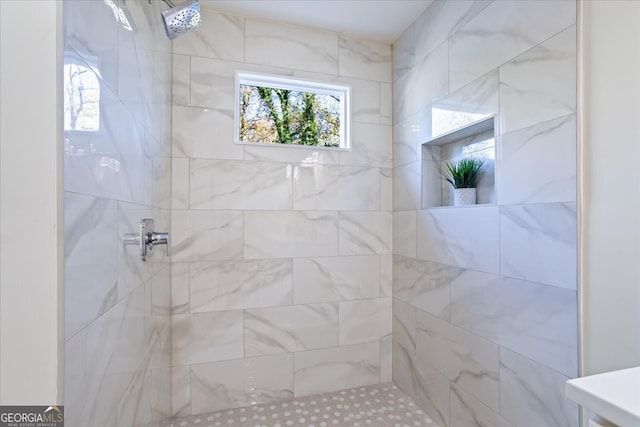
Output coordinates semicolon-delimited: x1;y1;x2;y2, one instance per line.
235;72;351;149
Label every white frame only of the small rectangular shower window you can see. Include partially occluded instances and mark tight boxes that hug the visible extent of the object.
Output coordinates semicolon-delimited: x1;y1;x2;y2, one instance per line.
233;71;351;151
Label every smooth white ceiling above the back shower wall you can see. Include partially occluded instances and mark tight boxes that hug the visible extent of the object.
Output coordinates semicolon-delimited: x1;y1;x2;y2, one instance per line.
200;0;433;43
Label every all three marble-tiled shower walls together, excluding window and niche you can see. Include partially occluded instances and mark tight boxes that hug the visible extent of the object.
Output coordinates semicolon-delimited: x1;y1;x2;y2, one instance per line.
64;0;578;427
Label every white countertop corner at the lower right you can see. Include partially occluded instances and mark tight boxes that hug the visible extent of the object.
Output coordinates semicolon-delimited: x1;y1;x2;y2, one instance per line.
566;366;640;427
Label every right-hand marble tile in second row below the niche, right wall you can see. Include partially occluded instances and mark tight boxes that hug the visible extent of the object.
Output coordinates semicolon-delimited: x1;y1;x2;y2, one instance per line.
451;270;578;377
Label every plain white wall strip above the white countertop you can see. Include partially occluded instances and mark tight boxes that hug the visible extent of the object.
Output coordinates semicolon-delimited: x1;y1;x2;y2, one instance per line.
580;1;640;375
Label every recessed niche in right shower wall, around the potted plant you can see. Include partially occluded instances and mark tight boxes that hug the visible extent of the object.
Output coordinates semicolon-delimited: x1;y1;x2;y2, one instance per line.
422;116;496;209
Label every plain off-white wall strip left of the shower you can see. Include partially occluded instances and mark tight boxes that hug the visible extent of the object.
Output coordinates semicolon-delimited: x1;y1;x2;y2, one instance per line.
0;1;62;405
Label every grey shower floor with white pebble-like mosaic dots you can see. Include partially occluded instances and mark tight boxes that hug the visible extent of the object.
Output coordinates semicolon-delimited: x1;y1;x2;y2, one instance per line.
165;383;438;427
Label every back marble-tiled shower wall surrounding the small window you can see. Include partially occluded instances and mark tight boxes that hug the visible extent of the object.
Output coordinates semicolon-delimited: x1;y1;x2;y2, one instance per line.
170;10;390;416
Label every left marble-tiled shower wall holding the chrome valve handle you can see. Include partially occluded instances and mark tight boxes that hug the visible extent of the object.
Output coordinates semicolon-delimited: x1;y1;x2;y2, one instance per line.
63;0;172;426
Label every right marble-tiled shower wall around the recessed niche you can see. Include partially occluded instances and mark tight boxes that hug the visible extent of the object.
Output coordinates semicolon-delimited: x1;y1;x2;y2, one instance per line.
392;0;578;427
